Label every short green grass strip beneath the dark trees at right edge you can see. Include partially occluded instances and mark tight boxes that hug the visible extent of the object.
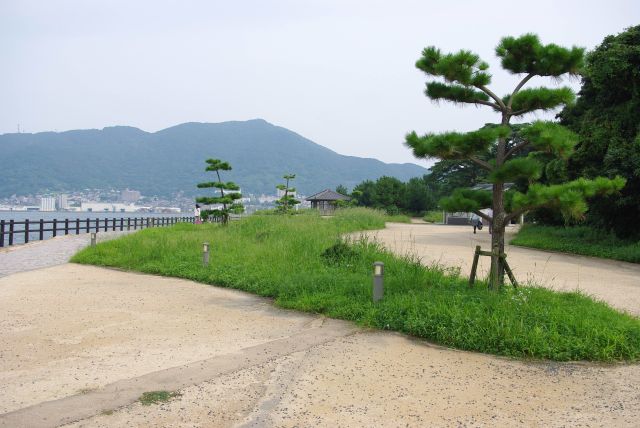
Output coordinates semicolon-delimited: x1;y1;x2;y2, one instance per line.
511;224;640;263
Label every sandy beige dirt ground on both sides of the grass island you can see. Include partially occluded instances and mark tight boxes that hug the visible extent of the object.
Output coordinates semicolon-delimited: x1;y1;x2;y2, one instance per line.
0;225;640;427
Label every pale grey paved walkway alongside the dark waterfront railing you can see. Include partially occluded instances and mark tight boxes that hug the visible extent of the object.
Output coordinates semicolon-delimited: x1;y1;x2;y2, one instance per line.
0;231;134;277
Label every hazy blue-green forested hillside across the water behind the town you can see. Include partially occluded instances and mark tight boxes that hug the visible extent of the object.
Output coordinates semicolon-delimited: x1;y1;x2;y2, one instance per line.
0;119;427;196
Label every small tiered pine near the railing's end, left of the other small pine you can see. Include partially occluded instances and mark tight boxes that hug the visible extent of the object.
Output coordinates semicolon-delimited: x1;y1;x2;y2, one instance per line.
196;159;244;224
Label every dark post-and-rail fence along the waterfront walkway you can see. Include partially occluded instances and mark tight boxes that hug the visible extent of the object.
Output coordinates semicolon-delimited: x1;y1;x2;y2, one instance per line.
0;217;195;247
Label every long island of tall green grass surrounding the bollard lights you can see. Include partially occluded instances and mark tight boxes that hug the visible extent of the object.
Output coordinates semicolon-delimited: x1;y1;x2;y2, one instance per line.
73;209;640;361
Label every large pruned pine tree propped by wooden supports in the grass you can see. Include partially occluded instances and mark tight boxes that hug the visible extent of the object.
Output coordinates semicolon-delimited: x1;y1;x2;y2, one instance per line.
406;34;625;288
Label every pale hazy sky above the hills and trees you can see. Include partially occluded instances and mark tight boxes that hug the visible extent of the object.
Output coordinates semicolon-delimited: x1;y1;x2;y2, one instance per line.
0;0;640;165
